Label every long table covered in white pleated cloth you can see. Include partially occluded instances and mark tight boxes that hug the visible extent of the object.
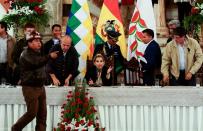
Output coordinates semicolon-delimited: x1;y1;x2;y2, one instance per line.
0;86;203;131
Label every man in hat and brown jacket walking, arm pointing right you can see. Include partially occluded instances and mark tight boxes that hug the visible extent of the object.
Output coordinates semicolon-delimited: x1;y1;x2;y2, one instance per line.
12;31;57;131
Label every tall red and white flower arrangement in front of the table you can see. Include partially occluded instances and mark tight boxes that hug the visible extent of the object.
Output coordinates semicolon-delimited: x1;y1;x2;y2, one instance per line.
54;81;104;131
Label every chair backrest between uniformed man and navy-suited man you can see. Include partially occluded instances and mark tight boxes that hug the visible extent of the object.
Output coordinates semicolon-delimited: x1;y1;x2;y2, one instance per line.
124;57;142;86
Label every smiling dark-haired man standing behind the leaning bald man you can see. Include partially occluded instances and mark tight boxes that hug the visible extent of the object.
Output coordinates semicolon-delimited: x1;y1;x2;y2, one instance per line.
44;24;62;55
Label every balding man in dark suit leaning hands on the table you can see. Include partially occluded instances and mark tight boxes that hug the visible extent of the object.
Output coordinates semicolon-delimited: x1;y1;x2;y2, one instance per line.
47;35;79;86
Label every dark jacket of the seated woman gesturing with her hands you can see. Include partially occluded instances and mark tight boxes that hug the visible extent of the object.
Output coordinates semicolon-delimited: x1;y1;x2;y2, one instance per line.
85;66;112;86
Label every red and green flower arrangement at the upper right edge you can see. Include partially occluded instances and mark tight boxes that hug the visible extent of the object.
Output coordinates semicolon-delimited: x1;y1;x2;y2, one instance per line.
183;0;203;40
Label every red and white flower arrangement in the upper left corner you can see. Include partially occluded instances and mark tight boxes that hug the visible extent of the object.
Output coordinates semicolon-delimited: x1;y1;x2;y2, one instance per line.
2;0;50;27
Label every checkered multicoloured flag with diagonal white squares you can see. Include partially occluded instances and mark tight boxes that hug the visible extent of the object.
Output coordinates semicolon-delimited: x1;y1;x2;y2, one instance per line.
66;0;94;77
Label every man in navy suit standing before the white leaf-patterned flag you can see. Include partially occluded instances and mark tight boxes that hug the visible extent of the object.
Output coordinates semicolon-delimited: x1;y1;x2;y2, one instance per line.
141;29;161;86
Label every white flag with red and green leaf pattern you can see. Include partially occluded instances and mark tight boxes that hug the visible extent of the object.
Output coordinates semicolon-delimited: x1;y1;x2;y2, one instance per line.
127;0;156;62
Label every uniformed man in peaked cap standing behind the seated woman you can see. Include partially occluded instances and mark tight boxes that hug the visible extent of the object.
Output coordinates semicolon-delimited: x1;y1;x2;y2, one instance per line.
94;30;125;85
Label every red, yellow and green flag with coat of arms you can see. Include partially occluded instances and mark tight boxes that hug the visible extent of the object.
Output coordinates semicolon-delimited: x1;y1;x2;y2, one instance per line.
95;0;127;58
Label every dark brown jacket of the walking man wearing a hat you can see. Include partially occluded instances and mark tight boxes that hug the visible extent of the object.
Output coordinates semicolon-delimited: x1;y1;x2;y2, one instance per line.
20;48;49;87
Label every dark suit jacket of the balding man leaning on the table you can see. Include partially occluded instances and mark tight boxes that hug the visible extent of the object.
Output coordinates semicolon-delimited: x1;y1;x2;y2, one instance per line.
47;44;79;85
